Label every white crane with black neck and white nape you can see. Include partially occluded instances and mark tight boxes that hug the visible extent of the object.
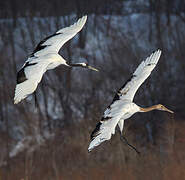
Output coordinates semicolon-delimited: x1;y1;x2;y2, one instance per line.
14;16;98;104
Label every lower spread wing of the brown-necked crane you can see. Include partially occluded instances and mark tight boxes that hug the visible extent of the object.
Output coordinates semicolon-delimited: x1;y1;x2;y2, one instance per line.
88;100;127;152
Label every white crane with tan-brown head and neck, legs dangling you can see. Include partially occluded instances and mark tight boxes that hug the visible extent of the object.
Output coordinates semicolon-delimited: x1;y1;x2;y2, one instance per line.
88;50;173;153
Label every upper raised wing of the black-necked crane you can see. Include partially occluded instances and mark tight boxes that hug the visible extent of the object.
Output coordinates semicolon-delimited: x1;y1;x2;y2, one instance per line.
31;16;87;57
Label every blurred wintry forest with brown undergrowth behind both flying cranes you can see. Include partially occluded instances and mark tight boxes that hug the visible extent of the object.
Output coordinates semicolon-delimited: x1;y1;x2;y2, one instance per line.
0;0;185;180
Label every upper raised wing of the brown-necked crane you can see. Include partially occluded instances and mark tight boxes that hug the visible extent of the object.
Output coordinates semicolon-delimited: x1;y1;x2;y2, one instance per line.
113;50;161;101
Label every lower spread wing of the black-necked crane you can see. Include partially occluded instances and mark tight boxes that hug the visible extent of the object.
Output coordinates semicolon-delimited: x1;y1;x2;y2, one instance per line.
14;57;49;104
